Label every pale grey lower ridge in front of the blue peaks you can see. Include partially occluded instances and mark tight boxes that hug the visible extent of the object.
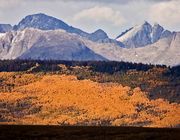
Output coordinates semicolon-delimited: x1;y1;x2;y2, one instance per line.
0;28;180;66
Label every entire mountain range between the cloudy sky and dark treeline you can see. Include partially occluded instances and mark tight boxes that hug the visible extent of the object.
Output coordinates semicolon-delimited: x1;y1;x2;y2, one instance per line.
0;13;180;66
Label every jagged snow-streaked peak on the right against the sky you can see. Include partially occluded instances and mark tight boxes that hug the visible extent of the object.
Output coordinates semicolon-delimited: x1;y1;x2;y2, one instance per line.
116;21;171;48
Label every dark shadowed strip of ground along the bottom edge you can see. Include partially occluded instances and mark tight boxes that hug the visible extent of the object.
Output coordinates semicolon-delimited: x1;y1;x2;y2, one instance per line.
0;125;180;140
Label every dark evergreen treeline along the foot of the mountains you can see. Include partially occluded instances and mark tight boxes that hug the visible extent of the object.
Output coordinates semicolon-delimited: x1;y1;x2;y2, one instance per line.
0;60;167;74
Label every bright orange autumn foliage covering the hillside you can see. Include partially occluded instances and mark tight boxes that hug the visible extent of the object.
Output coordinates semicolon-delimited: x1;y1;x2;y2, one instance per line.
0;74;180;127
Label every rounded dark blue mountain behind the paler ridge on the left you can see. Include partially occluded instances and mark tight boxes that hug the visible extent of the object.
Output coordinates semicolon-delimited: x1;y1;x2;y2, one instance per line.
13;13;116;42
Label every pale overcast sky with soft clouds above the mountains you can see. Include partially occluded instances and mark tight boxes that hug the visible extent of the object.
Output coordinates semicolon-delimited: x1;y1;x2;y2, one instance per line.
0;0;180;38
